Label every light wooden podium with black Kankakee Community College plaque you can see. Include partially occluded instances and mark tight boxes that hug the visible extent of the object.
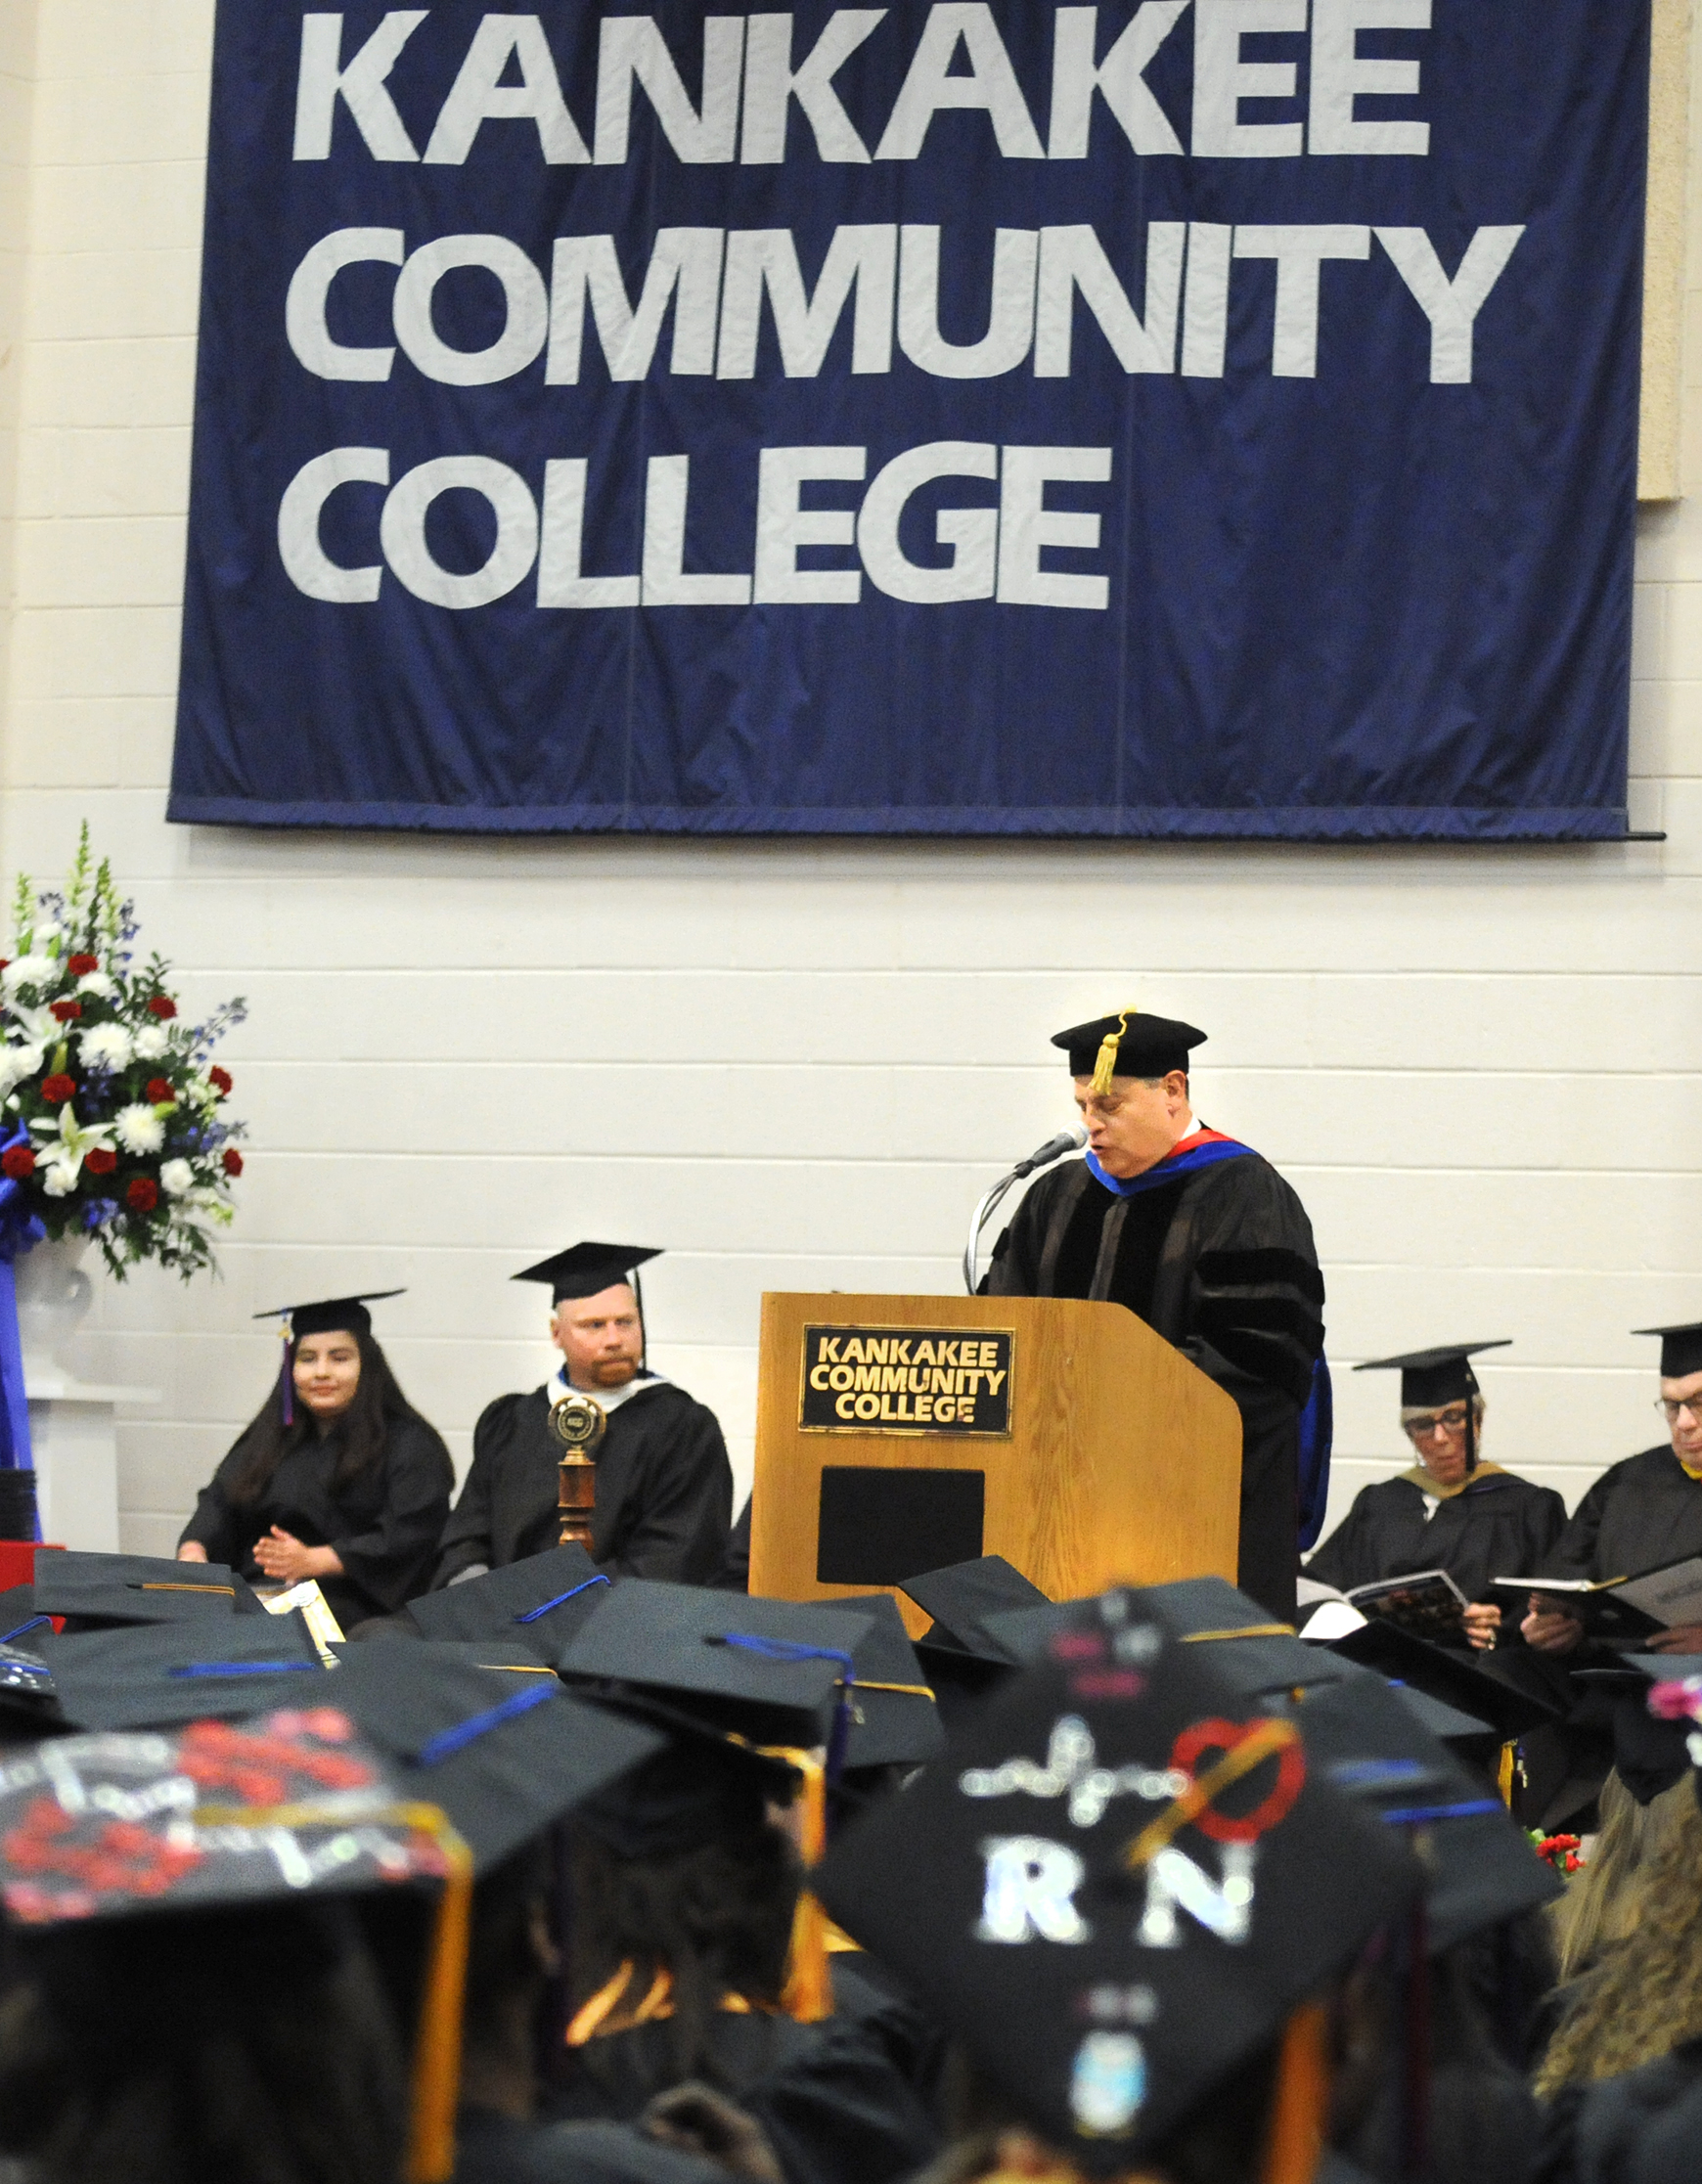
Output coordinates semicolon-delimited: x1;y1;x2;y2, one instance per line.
749;1291;1241;1625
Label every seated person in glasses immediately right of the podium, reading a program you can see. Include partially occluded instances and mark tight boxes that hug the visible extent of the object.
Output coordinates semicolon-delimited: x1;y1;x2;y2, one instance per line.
1307;1341;1567;1651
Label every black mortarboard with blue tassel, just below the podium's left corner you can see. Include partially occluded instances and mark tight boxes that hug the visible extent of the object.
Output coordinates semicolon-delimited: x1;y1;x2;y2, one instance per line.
558;1579;870;1747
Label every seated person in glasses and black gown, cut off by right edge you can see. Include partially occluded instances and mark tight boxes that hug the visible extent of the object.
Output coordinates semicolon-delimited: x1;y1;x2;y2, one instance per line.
1518;1323;1702;1653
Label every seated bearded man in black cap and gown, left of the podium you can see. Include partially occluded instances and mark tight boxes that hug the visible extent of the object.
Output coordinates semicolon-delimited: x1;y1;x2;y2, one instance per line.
432;1243;732;1590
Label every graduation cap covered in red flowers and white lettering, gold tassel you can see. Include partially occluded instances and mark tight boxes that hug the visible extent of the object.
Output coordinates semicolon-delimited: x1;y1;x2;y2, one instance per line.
0;1706;471;2184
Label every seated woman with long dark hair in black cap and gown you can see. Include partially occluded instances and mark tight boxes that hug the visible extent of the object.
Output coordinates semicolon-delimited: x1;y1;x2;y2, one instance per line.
177;1288;455;1629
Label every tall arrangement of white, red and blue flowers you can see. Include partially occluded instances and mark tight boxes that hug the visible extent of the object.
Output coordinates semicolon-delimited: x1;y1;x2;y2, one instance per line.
0;825;246;1280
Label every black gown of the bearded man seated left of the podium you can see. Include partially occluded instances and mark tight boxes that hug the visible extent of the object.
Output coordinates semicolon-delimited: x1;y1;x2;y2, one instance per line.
432;1380;732;1590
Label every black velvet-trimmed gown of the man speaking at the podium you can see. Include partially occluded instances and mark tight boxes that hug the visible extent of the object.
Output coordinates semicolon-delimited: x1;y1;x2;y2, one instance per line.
985;1153;1324;1623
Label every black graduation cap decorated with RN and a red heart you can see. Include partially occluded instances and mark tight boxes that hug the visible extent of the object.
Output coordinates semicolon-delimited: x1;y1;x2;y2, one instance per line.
817;1592;1422;2175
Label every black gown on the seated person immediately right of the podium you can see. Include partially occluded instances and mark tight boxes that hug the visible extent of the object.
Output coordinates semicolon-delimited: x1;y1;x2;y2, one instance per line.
1307;1470;1567;1621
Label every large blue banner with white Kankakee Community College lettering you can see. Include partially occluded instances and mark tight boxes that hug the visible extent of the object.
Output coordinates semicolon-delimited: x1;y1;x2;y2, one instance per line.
170;0;1649;841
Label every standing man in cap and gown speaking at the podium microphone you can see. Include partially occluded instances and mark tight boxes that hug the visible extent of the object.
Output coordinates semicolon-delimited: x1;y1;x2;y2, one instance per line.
983;1009;1328;1623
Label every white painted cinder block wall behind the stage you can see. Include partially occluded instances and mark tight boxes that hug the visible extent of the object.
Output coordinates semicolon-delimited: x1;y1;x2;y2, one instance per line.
0;0;1702;1550
